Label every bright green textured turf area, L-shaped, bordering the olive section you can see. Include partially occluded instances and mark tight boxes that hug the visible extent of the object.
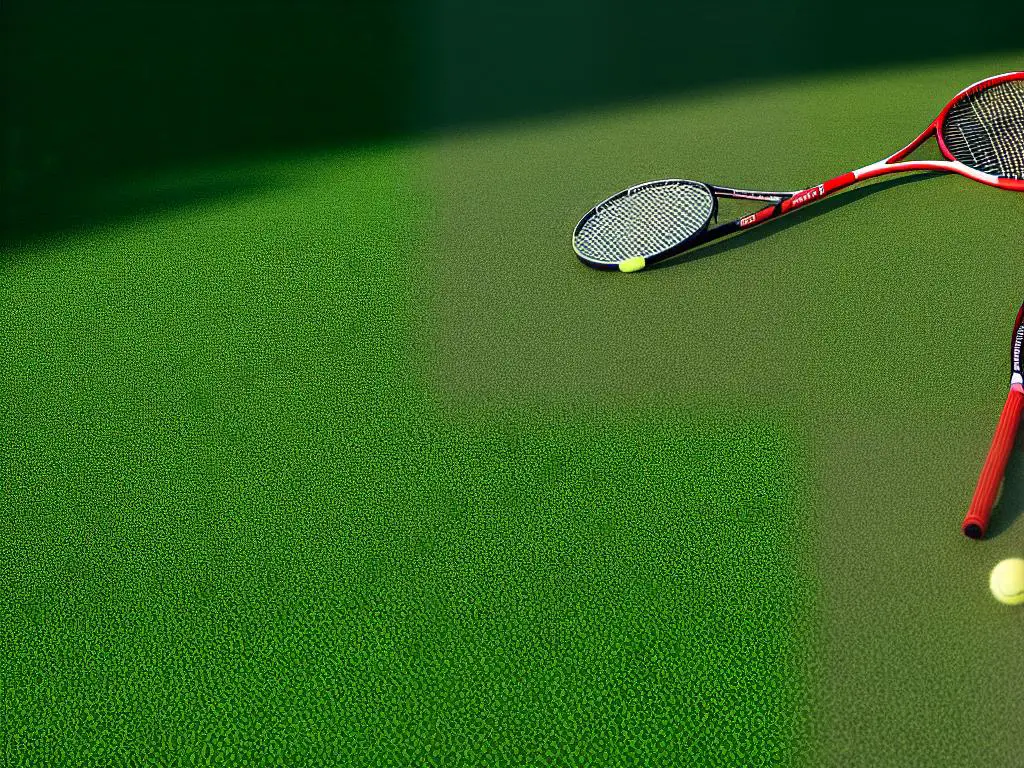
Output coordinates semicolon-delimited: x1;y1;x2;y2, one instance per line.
0;147;810;766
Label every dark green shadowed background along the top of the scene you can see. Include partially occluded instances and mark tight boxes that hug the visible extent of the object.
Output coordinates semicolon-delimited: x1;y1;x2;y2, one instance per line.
0;0;1024;240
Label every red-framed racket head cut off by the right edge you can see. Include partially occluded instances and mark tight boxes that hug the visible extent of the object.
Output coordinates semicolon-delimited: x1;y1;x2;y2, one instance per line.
935;72;1024;190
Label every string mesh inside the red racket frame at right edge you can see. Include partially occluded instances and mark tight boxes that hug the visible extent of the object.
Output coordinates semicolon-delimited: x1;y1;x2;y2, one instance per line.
942;80;1024;179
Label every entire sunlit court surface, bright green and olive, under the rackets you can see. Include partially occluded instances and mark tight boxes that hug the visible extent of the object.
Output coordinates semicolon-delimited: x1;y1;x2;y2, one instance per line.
6;53;1024;766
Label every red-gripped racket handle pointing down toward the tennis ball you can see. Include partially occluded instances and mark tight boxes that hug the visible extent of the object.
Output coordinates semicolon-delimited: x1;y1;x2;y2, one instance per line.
961;304;1024;539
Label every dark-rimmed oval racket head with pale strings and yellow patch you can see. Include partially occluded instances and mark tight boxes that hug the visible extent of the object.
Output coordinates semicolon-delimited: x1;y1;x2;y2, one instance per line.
572;179;718;272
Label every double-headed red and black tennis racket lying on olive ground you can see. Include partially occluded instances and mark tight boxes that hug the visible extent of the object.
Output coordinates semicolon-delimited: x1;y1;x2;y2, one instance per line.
572;72;1024;272
